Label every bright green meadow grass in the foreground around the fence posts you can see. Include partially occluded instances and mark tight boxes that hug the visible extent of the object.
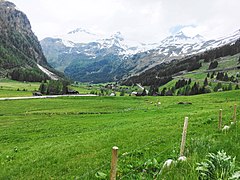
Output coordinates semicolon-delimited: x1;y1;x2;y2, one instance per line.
0;91;240;179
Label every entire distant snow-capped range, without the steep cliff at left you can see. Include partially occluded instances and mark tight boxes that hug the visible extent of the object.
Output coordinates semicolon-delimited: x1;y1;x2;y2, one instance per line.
41;28;240;83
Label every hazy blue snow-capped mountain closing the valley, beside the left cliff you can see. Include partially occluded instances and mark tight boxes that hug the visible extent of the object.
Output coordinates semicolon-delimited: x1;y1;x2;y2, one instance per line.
41;28;154;83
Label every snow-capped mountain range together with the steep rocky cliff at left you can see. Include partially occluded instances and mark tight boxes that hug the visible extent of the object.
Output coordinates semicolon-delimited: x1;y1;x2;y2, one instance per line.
0;0;240;83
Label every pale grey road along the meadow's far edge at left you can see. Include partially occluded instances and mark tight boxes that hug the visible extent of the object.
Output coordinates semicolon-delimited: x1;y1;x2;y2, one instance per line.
0;94;97;101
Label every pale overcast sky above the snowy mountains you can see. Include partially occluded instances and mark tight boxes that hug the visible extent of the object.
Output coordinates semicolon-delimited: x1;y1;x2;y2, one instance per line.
10;0;240;43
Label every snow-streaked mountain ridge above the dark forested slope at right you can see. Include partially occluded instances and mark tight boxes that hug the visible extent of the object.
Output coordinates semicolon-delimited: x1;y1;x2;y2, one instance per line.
125;30;240;75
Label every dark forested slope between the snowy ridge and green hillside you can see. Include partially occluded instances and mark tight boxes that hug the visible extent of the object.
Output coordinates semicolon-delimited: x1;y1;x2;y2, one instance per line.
122;36;240;88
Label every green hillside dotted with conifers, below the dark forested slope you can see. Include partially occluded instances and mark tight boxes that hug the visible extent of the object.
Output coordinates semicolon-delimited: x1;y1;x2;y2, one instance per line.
160;54;240;95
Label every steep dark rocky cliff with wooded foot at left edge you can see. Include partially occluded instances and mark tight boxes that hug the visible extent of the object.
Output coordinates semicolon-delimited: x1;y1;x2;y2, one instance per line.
0;0;60;81
